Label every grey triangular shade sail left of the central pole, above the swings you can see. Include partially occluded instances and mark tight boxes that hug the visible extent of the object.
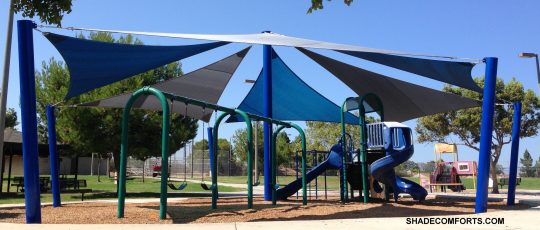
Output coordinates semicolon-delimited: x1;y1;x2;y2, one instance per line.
78;47;249;122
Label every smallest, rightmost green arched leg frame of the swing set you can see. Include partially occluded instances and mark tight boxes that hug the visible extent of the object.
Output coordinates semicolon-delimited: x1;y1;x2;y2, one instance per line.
271;123;307;205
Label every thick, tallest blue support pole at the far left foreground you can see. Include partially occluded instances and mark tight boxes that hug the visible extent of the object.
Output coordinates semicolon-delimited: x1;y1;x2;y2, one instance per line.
17;20;41;224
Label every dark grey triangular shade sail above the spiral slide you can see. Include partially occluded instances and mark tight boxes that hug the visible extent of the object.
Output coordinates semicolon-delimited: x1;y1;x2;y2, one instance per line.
298;48;481;121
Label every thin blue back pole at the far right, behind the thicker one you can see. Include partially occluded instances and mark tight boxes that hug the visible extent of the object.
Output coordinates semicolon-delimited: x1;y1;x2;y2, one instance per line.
506;102;521;205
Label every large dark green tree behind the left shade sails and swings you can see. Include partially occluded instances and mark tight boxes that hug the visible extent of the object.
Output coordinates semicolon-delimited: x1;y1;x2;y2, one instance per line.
36;33;197;170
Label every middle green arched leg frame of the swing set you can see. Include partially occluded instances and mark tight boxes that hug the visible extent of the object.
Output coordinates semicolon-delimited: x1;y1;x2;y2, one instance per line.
211;109;253;209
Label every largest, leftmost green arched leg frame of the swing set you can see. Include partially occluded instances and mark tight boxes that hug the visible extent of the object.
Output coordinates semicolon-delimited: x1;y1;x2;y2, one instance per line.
118;87;170;220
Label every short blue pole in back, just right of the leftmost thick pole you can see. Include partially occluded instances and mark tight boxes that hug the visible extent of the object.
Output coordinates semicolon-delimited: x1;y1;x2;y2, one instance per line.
46;105;62;208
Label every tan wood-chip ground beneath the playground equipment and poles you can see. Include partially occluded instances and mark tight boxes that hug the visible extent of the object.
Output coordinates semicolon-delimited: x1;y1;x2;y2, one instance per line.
0;198;529;224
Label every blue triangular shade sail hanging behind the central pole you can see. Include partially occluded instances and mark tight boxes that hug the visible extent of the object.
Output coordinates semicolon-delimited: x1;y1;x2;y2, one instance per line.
228;50;358;124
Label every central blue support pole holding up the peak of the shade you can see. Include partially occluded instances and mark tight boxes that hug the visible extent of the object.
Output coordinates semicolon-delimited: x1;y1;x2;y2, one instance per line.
263;45;272;201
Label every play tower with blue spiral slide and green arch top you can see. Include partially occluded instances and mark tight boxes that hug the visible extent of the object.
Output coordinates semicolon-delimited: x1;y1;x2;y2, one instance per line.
341;93;427;203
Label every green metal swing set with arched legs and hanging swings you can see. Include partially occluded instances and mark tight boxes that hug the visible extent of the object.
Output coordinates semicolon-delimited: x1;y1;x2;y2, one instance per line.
117;87;307;219
